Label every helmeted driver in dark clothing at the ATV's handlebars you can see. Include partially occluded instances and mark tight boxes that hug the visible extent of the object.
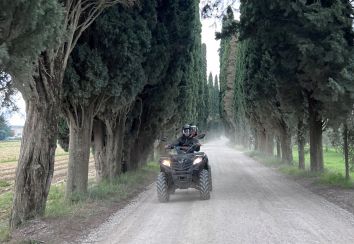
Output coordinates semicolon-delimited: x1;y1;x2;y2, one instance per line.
166;124;200;152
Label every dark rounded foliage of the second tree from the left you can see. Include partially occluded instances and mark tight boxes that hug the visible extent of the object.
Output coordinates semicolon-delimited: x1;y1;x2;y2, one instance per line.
64;1;154;109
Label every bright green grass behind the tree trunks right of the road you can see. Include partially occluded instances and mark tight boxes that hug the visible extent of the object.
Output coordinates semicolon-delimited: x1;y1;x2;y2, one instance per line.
246;147;354;189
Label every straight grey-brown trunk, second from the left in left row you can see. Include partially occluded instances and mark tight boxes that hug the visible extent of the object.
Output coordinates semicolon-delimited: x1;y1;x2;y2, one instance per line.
65;109;93;199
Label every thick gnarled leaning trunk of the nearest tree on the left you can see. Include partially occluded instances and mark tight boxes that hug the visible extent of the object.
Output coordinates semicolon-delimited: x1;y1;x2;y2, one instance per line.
10;58;61;229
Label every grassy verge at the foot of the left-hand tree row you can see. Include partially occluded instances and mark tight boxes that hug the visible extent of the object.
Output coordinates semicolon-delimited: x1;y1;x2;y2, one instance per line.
0;162;159;243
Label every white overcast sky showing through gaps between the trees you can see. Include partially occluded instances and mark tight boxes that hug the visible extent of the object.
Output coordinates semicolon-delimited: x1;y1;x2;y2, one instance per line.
8;4;239;125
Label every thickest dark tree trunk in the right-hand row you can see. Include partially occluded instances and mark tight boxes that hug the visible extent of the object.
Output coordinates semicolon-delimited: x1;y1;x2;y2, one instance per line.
308;98;323;171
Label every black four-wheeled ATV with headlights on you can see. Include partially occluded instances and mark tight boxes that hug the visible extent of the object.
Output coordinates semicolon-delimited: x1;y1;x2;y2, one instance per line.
156;145;212;202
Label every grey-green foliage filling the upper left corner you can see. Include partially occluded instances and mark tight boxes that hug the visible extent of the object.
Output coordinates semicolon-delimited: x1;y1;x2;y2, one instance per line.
0;0;64;79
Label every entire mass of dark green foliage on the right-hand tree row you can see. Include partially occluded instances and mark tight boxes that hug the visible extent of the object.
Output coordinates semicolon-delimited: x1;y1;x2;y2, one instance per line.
220;0;354;162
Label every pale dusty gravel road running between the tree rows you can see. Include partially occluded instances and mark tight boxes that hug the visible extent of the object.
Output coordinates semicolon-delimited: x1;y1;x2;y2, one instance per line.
82;140;354;244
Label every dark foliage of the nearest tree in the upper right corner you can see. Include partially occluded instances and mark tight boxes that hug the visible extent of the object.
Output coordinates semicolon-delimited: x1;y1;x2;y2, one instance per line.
241;0;353;121
